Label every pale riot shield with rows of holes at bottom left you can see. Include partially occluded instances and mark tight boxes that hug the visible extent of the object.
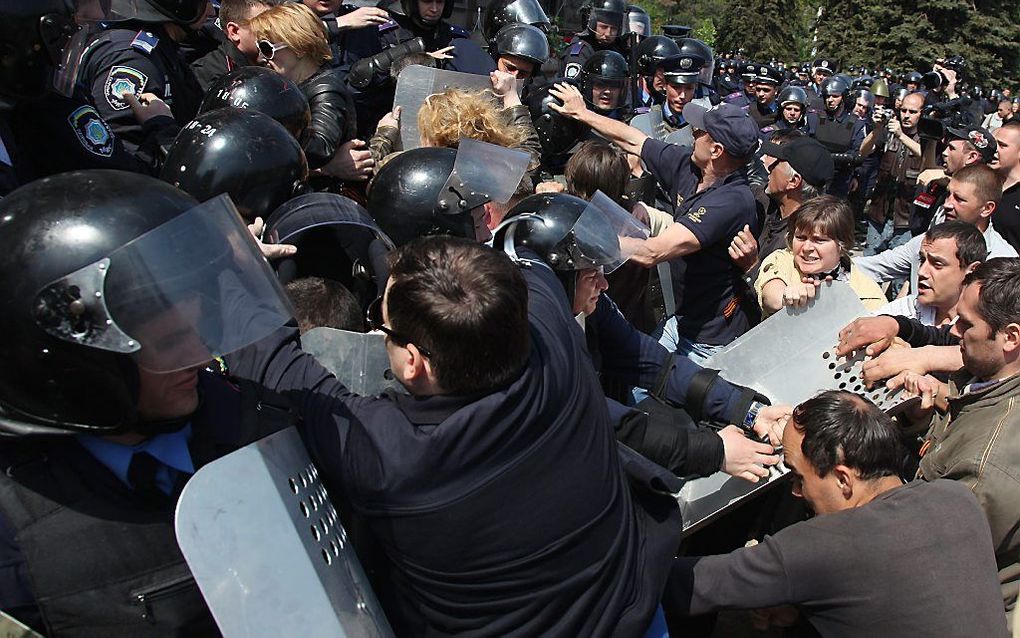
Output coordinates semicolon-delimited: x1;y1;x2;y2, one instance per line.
175;428;393;638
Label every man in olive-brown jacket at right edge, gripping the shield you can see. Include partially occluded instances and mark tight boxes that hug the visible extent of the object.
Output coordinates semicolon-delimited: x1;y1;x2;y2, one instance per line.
900;258;1020;616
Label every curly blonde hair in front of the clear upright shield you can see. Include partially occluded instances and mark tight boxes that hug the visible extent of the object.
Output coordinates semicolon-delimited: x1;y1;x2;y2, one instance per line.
418;89;525;148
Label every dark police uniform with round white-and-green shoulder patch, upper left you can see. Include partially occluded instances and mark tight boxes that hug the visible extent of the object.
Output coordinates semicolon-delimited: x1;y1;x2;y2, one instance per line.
79;24;204;163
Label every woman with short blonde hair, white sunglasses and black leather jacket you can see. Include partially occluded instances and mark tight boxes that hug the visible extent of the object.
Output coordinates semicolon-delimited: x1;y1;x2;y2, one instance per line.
250;3;357;174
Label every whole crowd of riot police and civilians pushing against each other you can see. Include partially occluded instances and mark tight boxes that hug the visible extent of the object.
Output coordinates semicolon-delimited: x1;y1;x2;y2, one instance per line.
0;0;1020;638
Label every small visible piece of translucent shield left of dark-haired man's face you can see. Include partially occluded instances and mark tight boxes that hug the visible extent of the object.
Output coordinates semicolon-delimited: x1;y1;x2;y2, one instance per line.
301;328;407;396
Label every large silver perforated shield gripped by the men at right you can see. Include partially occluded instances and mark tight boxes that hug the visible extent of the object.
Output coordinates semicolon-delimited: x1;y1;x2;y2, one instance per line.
677;282;906;535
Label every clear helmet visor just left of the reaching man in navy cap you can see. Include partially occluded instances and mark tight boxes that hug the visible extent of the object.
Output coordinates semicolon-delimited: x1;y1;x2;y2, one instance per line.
570;191;649;273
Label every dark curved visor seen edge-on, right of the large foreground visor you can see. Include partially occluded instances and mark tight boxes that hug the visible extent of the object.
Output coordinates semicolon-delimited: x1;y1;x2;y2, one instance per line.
265;193;394;250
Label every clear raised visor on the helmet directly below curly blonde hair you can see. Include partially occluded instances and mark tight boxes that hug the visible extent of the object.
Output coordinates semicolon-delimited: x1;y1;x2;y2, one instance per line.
440;138;531;213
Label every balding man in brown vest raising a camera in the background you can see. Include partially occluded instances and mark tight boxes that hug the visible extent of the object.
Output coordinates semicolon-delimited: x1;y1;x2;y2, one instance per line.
861;93;924;255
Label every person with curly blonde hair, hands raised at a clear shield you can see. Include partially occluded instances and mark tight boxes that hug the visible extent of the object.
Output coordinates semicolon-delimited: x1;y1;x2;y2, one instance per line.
370;71;542;177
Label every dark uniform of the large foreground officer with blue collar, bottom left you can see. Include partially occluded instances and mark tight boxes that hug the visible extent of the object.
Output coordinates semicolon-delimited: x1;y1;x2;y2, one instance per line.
0;373;291;636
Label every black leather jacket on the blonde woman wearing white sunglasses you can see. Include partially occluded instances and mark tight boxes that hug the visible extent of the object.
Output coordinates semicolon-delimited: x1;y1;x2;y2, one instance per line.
301;65;358;168
